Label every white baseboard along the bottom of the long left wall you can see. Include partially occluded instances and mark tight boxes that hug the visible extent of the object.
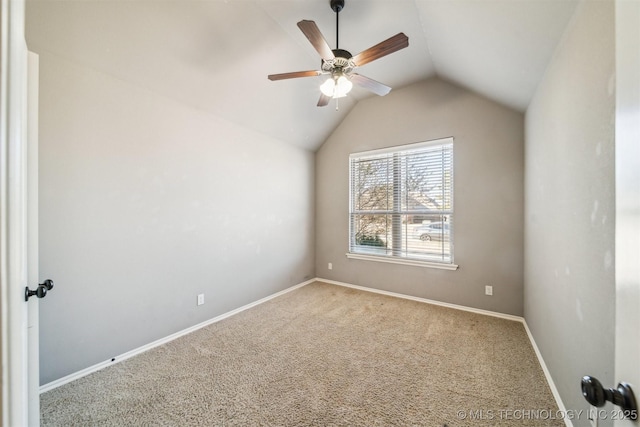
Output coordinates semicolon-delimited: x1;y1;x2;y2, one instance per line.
40;279;316;393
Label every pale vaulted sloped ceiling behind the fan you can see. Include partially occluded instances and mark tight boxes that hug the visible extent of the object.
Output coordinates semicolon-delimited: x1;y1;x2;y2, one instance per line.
26;0;578;150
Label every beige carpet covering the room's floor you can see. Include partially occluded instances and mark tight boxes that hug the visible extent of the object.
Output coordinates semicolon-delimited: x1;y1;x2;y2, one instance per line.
41;283;564;427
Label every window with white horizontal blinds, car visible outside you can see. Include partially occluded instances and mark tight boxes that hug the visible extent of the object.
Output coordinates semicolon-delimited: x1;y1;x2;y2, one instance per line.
347;138;457;269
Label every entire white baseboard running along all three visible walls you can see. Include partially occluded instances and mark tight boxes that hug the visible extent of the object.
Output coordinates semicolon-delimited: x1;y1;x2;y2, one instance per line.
40;277;573;427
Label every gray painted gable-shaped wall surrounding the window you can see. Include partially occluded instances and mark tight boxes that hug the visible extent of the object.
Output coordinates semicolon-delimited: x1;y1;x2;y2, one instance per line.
316;78;524;315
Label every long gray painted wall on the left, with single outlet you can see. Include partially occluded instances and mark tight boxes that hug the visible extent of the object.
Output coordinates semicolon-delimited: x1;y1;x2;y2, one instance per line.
39;52;314;384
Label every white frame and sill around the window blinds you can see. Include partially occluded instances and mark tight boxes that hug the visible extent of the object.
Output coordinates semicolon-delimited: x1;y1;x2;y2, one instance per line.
346;137;458;270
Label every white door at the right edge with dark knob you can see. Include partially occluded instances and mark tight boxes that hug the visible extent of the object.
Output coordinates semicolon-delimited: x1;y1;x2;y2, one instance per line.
607;0;640;427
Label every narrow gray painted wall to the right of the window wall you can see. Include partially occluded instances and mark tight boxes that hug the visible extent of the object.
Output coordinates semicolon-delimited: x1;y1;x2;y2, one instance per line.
524;1;615;426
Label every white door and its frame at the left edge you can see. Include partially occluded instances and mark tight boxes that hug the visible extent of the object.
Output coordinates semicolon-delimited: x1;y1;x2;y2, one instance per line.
0;0;39;426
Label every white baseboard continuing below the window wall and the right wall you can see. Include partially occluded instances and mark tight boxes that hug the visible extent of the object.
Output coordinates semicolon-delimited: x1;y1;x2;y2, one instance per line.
316;278;573;427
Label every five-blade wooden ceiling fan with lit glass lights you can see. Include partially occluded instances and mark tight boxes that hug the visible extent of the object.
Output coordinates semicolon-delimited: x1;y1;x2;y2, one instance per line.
268;0;409;107
